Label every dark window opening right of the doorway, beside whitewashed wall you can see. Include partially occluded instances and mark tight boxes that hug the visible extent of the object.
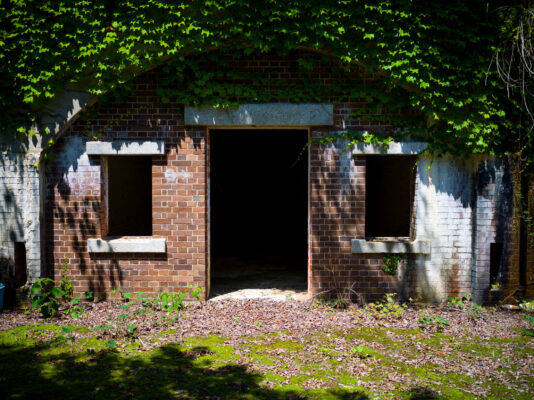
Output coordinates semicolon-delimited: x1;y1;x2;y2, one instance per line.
365;155;416;238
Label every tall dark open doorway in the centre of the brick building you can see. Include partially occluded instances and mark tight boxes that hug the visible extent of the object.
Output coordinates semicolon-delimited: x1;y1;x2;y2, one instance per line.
210;129;308;297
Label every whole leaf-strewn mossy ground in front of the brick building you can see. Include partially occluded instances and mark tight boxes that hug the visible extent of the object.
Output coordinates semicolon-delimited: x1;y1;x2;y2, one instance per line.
0;304;534;399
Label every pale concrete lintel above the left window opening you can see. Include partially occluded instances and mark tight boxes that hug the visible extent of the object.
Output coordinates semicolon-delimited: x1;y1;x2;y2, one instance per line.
86;140;165;156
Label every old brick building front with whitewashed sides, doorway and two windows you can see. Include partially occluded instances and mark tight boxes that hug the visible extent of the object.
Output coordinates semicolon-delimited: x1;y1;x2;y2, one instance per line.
0;53;534;302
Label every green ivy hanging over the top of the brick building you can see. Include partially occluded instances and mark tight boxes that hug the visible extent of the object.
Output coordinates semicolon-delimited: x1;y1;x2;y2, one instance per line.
0;0;534;158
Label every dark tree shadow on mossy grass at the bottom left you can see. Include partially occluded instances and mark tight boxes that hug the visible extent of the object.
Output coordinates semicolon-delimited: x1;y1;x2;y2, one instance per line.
0;343;368;400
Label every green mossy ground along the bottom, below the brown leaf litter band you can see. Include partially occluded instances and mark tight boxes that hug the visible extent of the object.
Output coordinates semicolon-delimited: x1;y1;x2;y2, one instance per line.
0;324;534;399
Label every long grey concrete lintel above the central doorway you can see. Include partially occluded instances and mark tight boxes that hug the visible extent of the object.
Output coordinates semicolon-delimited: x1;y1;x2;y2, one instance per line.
184;103;334;126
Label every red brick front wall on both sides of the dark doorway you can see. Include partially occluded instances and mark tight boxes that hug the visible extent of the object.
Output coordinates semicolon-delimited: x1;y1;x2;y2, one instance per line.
45;53;520;300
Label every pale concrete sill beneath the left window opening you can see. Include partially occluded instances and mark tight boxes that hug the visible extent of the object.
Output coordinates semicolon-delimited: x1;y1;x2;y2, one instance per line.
87;238;166;253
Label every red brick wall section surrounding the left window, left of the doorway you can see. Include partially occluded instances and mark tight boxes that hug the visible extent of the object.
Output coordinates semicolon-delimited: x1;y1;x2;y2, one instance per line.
45;84;207;296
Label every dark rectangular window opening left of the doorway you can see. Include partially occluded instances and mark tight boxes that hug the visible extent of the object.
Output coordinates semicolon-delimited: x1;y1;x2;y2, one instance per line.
108;156;152;236
